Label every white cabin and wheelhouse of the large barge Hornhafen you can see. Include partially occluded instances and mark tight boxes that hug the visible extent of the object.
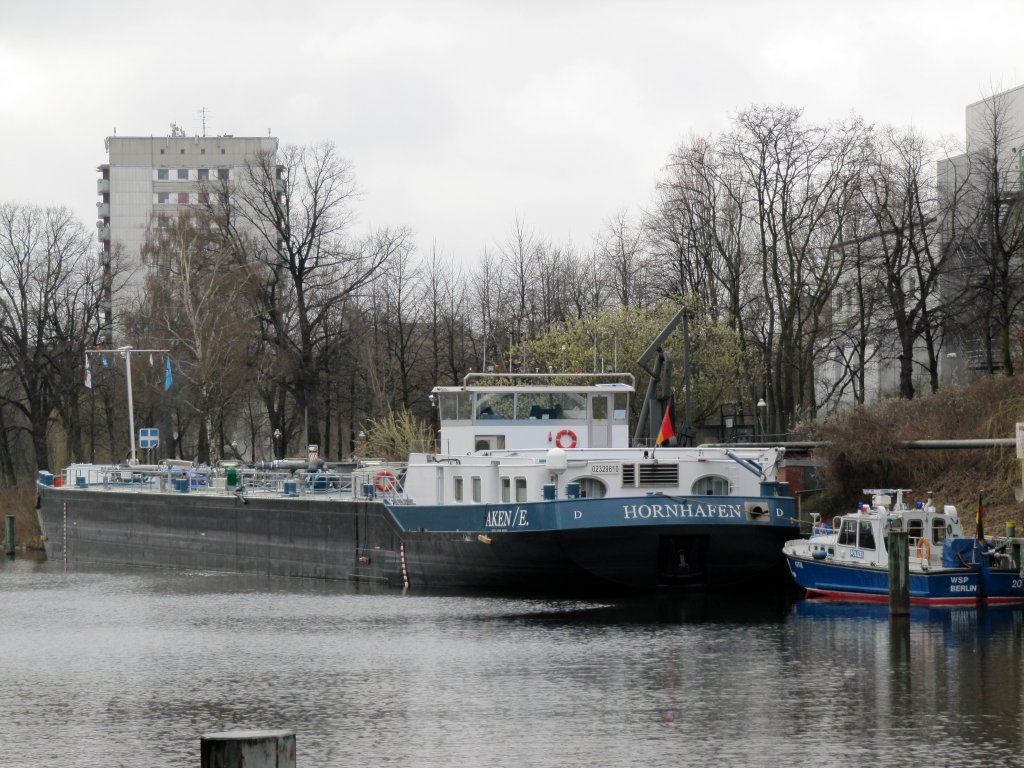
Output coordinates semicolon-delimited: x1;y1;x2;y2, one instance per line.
399;374;784;512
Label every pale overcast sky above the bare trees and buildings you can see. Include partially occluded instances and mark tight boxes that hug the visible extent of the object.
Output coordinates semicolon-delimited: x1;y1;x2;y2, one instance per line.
0;0;1024;262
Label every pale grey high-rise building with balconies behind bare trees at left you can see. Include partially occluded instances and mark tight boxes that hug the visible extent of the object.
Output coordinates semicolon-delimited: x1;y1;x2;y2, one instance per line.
96;123;278;341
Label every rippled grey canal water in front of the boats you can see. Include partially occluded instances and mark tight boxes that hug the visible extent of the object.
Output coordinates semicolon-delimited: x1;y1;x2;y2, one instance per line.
0;560;1024;768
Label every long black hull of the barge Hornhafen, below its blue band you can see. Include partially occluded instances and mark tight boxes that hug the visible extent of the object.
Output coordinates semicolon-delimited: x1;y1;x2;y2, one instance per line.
39;487;794;592
